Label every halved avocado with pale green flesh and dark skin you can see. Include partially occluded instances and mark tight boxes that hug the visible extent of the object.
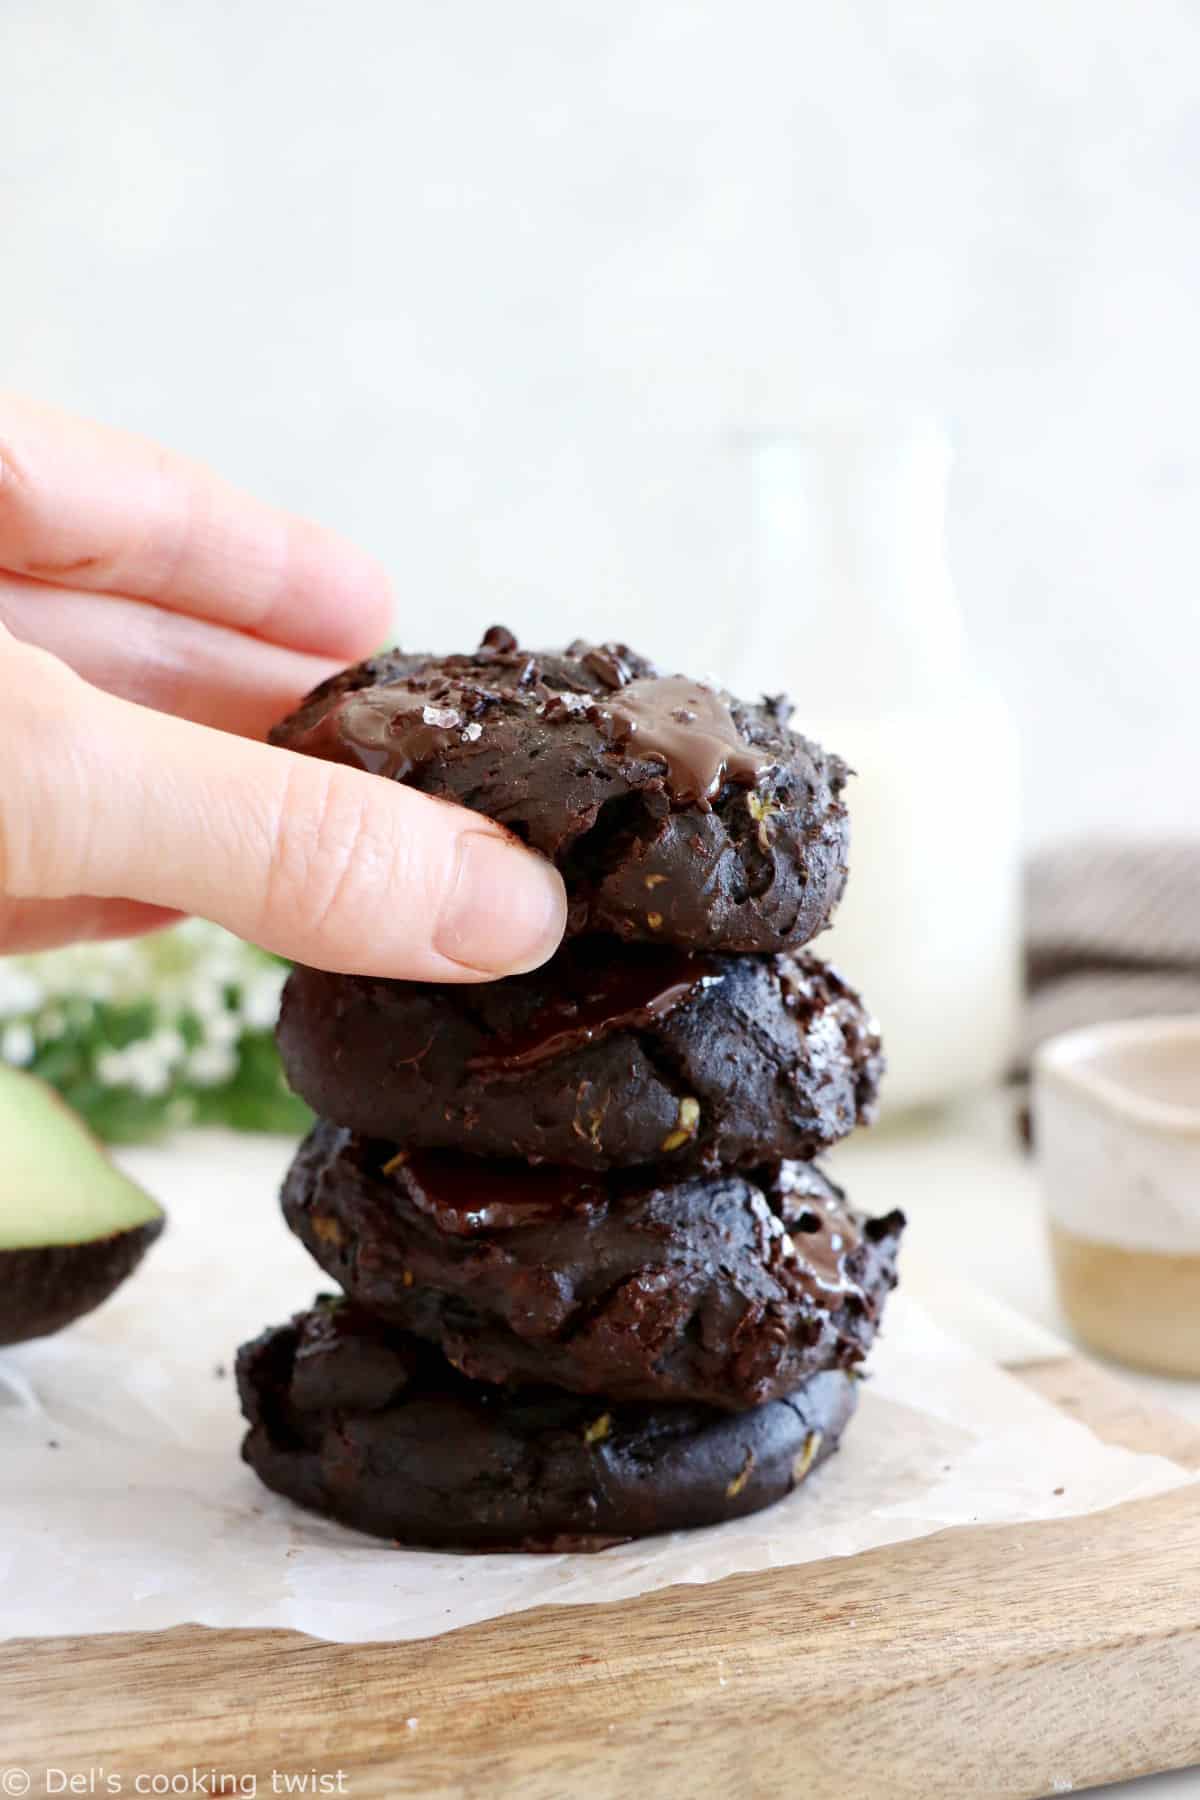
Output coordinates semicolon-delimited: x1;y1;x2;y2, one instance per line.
0;1067;164;1345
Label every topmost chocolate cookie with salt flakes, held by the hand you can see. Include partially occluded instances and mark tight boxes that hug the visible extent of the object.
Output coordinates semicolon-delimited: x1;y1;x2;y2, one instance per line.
272;625;847;952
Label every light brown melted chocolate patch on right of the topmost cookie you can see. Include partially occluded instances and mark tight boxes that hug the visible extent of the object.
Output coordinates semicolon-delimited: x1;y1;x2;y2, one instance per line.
599;675;779;806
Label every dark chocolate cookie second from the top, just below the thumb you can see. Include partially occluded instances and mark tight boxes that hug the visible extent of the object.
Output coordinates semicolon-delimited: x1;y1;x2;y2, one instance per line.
279;938;883;1170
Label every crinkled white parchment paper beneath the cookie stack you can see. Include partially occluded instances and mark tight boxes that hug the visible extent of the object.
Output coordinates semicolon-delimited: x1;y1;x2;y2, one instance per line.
0;1136;1187;1642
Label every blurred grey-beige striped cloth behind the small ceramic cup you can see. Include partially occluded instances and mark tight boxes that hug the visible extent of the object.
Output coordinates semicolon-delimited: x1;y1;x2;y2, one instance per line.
1024;841;1200;1060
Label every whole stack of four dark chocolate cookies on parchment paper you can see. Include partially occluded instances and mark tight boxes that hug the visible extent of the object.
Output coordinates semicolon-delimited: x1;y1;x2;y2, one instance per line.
237;626;903;1550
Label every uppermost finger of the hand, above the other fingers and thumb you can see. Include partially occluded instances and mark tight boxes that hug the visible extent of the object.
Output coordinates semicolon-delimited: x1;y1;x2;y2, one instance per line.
0;394;392;661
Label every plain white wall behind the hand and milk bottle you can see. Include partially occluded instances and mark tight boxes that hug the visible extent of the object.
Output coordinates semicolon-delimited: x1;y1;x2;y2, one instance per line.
0;0;1200;841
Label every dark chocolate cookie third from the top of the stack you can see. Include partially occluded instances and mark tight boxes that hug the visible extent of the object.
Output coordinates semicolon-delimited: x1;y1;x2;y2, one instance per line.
282;1121;903;1411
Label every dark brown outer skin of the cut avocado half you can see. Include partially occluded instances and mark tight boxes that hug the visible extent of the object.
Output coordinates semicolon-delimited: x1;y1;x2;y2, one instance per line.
0;1219;164;1345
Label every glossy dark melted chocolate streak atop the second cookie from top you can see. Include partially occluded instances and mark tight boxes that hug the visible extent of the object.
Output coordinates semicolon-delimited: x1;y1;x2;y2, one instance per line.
468;947;723;1075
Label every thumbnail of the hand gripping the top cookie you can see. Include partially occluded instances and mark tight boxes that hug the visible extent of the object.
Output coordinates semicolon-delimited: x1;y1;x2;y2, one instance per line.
434;832;567;976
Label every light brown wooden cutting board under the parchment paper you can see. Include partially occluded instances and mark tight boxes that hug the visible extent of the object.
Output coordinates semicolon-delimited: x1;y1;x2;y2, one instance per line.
0;1357;1200;1800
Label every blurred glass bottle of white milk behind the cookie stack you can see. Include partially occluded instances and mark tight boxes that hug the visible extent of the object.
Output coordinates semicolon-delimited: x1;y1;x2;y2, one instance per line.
752;421;1020;1114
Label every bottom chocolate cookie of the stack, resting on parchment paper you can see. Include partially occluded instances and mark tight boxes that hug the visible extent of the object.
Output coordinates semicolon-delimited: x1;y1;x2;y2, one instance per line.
237;1300;856;1550
